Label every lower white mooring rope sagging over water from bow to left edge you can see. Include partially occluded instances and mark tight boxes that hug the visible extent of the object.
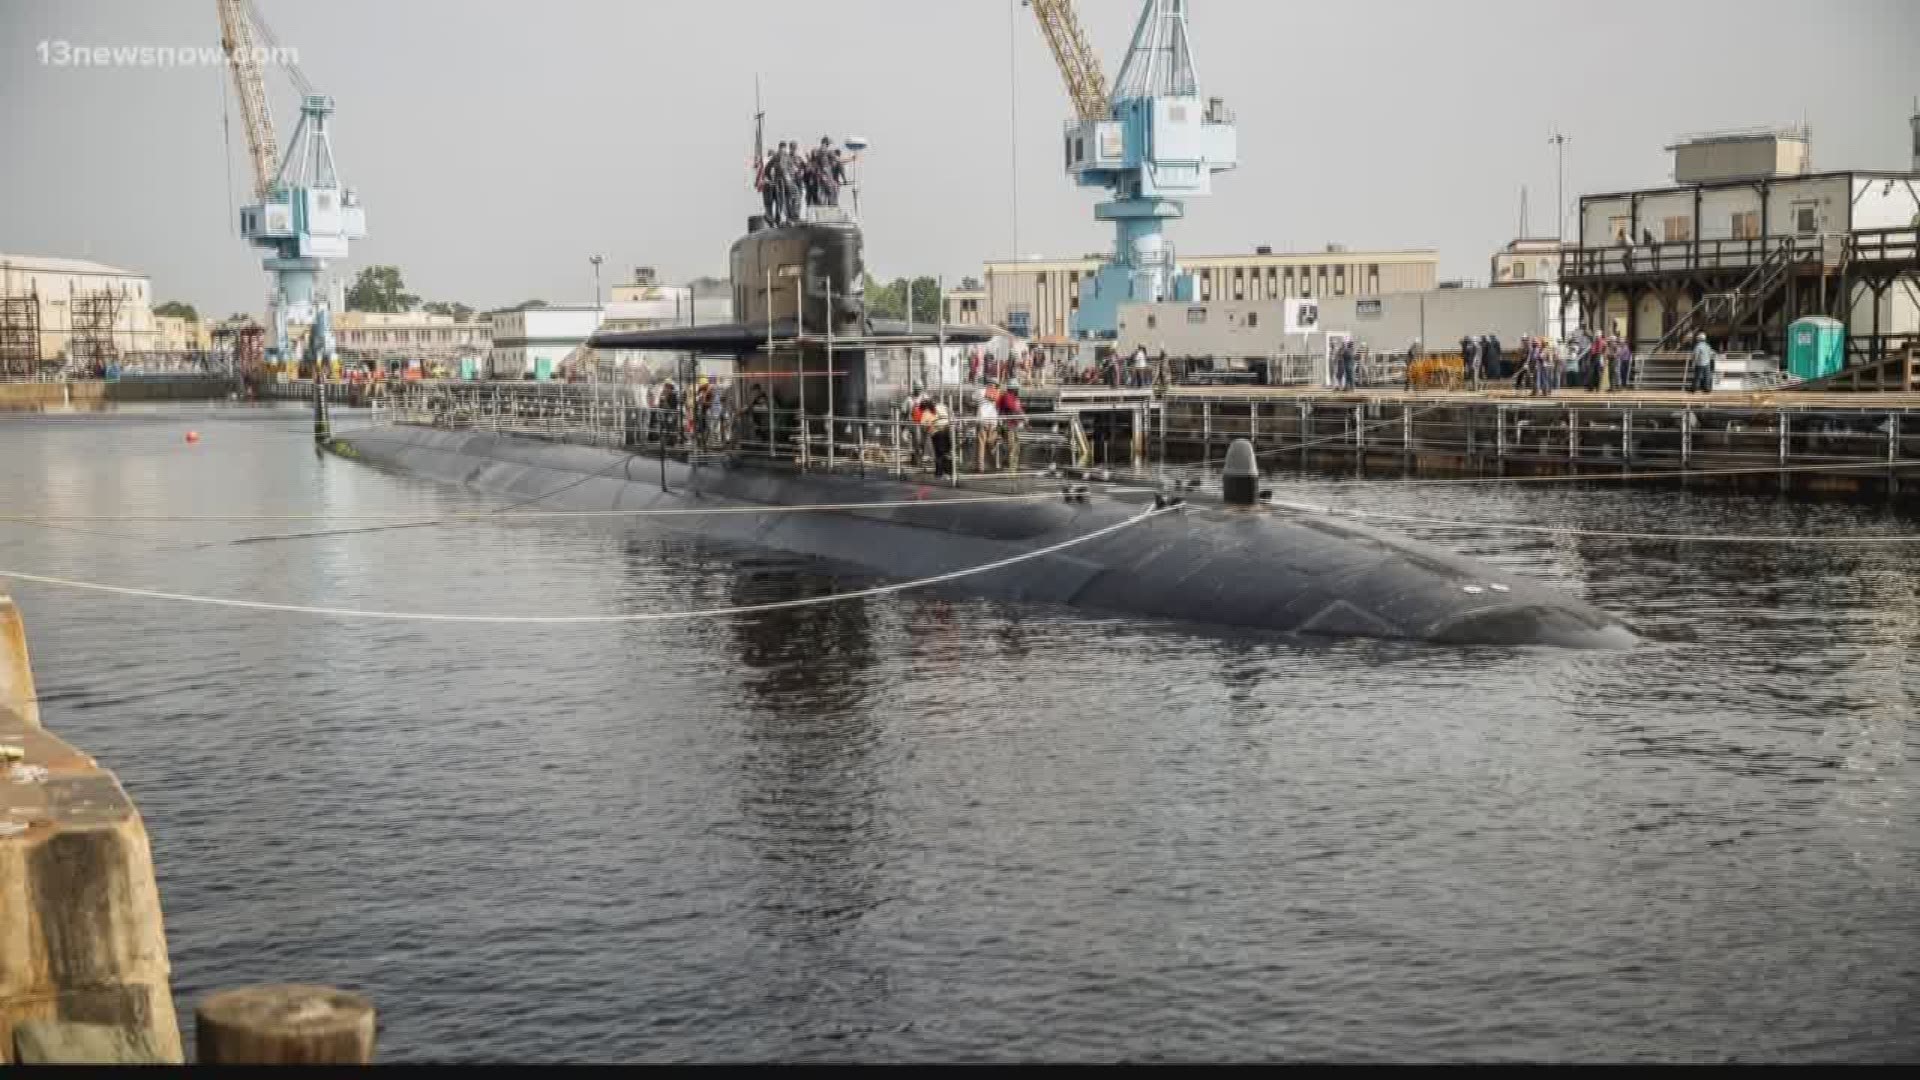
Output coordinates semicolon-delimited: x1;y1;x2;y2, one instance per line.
0;503;1183;625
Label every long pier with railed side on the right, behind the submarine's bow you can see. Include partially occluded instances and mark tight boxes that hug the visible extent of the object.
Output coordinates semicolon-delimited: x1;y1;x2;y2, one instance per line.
1150;386;1920;494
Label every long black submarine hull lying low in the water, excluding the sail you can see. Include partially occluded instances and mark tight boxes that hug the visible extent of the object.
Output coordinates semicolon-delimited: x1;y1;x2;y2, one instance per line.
338;425;1638;648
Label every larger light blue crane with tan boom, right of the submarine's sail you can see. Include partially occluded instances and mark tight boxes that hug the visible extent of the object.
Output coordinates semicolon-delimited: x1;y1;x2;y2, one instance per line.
1027;0;1238;338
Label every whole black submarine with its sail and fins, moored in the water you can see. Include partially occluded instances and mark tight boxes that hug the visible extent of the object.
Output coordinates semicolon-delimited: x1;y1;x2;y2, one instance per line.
334;208;1640;648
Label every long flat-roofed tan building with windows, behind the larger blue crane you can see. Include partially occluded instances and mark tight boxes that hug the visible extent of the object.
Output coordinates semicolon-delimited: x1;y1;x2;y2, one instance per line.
981;244;1440;342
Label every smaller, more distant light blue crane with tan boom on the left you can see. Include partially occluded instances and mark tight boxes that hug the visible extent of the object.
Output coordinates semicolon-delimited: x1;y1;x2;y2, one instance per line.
219;0;367;363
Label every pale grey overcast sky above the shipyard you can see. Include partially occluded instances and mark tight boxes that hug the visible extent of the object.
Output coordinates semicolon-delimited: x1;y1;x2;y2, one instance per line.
0;0;1920;313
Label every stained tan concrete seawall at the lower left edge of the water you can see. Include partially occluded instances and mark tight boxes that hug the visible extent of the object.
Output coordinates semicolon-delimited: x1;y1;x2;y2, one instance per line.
0;596;180;1063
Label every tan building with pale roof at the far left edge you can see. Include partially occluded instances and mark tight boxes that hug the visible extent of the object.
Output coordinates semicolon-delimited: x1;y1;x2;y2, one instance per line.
0;254;156;365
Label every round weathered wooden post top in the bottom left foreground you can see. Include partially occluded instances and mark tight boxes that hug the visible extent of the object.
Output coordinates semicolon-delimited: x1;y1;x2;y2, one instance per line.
194;984;374;1065
